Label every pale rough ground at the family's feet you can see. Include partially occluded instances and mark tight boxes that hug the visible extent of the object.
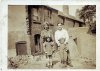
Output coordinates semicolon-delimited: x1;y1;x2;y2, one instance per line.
8;49;96;69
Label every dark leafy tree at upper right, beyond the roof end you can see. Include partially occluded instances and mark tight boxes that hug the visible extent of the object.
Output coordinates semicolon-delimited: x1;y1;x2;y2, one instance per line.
79;5;96;32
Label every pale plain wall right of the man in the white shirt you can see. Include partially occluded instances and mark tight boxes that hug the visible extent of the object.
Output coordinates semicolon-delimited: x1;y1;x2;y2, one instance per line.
68;27;96;59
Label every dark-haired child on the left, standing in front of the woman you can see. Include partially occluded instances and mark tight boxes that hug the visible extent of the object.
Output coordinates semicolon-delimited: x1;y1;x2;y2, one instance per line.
43;37;54;68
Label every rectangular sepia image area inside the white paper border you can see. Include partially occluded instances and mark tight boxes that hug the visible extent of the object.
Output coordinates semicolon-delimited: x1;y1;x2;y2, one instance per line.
7;5;96;69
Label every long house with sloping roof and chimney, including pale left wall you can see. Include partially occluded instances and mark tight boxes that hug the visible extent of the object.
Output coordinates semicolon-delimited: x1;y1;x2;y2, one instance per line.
8;5;95;60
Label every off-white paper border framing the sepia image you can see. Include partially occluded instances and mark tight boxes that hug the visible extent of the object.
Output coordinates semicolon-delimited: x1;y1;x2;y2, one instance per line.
0;0;100;71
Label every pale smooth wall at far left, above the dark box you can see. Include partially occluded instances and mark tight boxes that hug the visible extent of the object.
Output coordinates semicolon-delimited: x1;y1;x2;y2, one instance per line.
8;5;27;49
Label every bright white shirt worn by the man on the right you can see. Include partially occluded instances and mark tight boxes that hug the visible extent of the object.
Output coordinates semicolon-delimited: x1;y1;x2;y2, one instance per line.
55;29;69;46
